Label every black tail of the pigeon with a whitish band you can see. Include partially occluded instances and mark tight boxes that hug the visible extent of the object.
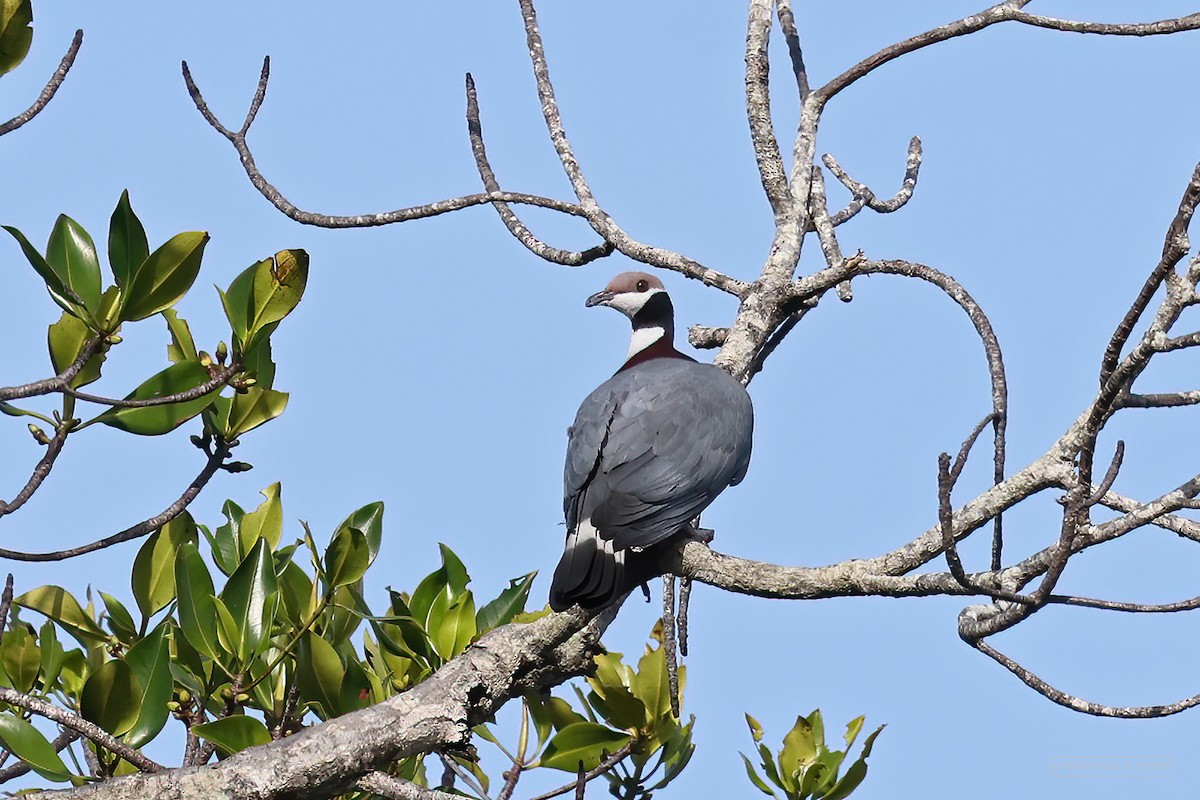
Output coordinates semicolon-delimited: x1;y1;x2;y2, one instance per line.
550;519;641;612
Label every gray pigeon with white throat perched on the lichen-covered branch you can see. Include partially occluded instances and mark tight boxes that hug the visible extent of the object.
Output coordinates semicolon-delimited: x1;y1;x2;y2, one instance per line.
550;272;754;610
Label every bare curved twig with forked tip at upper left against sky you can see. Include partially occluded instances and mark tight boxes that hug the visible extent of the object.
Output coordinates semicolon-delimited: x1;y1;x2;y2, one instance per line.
182;56;590;228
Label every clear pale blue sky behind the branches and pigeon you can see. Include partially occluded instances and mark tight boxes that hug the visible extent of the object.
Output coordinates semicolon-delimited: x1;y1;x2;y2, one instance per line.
0;0;1200;800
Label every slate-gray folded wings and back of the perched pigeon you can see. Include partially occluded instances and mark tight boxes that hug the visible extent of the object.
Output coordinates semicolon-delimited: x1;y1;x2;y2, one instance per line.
564;359;754;551
